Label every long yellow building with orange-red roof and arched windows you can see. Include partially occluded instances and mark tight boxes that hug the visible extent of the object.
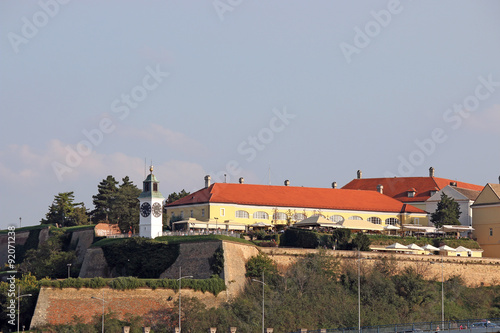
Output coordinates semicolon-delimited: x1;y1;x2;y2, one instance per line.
166;176;427;230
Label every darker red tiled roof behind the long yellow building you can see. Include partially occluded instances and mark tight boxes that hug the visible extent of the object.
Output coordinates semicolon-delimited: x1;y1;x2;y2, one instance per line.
342;177;483;202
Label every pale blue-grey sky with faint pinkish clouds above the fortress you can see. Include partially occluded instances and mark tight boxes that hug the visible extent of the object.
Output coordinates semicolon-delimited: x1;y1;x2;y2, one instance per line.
0;0;500;229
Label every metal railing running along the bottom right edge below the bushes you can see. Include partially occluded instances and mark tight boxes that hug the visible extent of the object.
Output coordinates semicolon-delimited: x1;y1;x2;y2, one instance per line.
291;318;500;333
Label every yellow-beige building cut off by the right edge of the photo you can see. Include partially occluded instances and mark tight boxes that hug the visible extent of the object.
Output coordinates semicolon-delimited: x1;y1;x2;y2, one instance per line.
472;184;500;258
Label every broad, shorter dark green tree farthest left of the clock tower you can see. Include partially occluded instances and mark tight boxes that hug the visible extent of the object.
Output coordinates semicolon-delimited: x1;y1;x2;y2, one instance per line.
40;192;89;227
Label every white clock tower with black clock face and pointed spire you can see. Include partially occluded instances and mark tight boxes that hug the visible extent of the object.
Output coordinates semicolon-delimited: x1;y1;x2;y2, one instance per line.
138;166;165;238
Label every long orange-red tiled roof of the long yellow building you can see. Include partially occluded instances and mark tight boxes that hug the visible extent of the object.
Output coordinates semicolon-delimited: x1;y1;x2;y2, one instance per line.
167;183;425;213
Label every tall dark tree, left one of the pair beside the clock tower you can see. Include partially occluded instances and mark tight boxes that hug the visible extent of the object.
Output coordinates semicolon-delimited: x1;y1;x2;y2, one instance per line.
92;175;118;222
